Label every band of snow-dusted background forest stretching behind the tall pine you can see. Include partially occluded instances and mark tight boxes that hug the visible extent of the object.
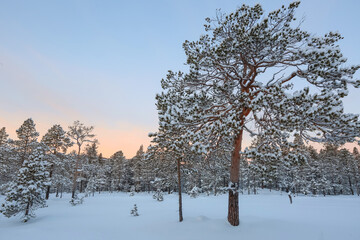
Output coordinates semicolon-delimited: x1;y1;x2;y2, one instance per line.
0;118;360;221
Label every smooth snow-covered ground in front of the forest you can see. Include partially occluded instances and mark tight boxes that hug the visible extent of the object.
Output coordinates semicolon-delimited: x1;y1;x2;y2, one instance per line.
0;191;360;240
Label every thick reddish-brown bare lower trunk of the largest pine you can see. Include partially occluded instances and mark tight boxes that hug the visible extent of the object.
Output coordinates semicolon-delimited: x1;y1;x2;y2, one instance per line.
228;129;243;226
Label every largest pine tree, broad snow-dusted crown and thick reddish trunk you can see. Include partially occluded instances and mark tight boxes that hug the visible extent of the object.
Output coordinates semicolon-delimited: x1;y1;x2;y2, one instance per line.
157;2;360;226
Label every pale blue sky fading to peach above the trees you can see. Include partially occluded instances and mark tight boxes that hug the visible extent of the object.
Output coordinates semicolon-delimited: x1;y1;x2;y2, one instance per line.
0;0;360;158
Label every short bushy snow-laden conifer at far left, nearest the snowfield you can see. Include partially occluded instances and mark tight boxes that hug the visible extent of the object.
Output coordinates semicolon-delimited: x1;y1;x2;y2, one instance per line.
1;146;49;222
